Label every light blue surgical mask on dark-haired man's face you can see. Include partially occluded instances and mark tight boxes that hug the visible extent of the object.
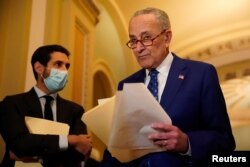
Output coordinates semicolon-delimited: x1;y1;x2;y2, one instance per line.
43;68;68;93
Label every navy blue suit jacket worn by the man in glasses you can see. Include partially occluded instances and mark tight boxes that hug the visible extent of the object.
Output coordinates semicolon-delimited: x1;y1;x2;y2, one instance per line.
102;55;235;167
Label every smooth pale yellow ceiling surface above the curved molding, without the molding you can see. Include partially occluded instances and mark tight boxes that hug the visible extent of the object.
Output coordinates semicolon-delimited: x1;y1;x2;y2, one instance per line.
114;0;250;50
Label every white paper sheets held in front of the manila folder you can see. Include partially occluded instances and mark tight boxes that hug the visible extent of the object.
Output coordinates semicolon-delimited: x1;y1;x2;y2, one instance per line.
108;84;171;149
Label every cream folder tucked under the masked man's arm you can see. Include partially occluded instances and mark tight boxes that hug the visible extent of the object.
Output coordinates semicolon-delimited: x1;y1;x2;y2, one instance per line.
25;116;69;135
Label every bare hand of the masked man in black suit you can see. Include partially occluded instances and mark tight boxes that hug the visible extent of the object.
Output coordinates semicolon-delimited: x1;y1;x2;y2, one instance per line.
68;135;92;157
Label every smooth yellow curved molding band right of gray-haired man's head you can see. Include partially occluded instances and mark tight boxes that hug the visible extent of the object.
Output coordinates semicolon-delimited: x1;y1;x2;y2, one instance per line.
172;21;250;58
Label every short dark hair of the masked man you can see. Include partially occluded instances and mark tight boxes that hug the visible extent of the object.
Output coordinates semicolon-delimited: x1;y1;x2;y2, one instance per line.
31;44;70;80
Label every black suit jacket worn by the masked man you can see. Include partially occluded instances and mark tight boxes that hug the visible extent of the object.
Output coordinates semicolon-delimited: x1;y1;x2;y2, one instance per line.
0;88;86;166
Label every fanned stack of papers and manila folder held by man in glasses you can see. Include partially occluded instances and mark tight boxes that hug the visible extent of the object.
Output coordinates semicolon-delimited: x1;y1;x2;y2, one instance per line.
83;83;171;162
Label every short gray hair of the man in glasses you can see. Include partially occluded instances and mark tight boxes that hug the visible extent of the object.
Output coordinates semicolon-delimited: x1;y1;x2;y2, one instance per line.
130;7;171;30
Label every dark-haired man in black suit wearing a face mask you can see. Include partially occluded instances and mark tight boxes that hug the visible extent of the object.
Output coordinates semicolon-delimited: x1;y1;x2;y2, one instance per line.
0;45;92;167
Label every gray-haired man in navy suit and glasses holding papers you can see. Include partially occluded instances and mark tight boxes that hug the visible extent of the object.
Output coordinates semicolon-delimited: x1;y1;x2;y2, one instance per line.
101;8;235;167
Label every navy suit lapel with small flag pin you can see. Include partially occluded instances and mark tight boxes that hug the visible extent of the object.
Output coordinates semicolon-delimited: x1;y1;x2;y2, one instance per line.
160;56;188;111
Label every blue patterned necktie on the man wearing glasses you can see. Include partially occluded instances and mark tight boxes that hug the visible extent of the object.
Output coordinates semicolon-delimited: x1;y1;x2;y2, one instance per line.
148;69;159;101
